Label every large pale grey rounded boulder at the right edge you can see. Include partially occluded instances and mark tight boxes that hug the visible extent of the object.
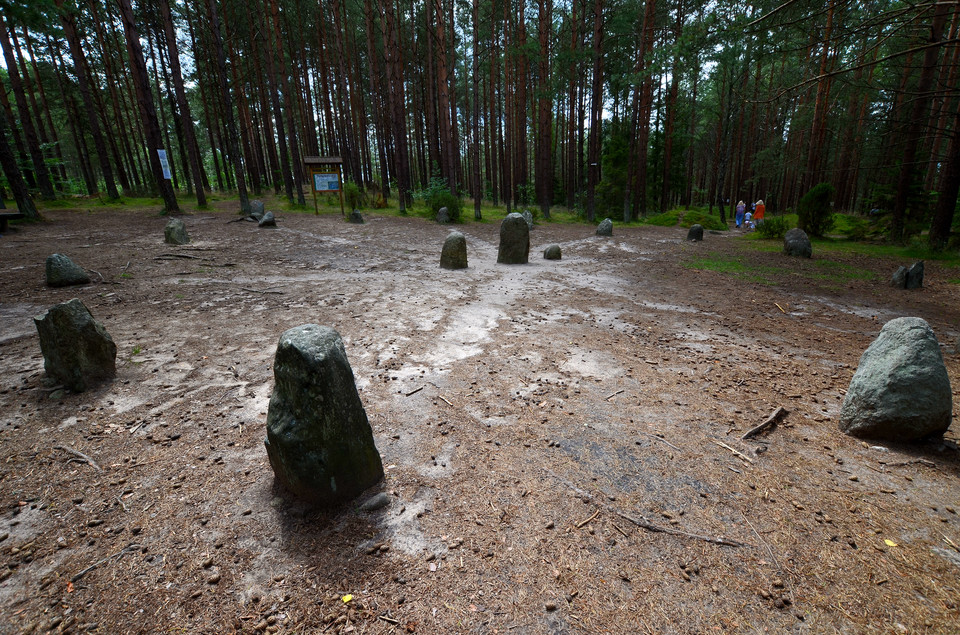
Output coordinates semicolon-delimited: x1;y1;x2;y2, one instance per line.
840;317;953;441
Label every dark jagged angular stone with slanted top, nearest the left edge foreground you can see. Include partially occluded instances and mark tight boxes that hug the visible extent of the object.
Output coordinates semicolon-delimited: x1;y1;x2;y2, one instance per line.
33;298;117;392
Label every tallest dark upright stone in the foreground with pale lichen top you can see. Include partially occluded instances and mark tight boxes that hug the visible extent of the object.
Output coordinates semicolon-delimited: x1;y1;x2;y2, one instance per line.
264;324;383;505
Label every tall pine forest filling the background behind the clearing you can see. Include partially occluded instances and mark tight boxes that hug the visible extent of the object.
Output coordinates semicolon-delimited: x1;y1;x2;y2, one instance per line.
0;0;960;246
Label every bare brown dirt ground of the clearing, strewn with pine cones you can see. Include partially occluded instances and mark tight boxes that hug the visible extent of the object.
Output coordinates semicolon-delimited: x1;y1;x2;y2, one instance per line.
0;202;960;633
